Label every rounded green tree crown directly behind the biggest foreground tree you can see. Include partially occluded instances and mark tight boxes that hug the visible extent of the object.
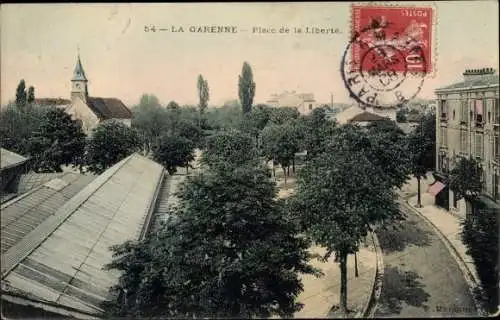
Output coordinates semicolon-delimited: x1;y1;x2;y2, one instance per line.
201;130;258;167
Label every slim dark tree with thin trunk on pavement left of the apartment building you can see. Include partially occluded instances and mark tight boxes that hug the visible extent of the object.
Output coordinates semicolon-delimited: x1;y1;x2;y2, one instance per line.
408;114;436;207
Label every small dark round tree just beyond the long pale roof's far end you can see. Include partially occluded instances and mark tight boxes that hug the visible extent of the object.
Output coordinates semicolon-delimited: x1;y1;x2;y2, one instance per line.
153;134;194;175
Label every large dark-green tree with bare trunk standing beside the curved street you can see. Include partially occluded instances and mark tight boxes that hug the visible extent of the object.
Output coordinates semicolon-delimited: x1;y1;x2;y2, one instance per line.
290;133;402;313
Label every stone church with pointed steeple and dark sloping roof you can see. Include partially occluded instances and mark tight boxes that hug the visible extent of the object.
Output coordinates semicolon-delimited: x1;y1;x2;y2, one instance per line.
35;55;132;134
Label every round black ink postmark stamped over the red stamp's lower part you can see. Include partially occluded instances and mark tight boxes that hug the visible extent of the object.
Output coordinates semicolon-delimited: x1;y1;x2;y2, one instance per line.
340;23;427;108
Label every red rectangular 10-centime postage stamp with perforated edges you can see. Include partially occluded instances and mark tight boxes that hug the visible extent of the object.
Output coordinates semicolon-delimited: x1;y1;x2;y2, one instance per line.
351;5;433;74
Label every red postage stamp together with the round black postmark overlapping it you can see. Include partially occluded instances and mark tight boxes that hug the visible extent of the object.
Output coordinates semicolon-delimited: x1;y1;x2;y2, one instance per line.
341;5;433;108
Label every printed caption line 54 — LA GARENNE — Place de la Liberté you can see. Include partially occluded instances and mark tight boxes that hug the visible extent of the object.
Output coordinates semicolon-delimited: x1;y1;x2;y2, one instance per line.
144;24;341;34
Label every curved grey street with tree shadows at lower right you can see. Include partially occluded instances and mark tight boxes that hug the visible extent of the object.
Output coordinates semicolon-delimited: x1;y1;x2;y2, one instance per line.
375;205;477;317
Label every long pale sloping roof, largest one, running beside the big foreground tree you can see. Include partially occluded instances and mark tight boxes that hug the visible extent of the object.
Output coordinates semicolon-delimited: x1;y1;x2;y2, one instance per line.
2;154;164;314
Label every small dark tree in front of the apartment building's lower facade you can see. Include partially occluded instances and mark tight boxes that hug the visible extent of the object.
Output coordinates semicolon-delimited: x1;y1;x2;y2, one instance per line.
449;157;483;218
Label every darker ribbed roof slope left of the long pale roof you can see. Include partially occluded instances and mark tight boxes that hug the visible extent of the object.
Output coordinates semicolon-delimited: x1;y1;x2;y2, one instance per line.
1;172;95;254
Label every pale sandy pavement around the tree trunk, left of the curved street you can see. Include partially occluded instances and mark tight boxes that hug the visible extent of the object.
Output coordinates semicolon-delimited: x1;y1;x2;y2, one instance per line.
294;237;377;318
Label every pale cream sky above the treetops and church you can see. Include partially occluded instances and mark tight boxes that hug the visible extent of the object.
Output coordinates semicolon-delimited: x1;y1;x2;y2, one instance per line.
0;1;499;106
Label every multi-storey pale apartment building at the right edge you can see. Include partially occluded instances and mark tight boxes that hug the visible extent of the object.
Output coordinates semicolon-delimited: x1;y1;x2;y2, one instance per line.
433;68;500;215
